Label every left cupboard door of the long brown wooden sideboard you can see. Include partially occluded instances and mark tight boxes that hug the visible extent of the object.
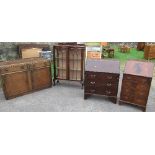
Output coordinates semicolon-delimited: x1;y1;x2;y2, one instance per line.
2;71;31;99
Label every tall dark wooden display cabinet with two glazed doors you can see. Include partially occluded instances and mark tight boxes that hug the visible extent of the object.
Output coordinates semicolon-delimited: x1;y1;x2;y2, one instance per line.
53;45;85;86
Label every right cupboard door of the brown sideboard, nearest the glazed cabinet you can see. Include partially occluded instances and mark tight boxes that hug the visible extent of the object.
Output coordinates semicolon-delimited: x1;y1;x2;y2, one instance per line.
31;67;52;90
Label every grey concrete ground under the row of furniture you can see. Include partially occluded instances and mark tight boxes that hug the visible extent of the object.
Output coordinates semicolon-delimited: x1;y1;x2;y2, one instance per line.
0;74;155;112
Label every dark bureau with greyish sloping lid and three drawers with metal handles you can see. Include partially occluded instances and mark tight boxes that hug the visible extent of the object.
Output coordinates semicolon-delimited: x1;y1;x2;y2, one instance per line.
84;60;120;103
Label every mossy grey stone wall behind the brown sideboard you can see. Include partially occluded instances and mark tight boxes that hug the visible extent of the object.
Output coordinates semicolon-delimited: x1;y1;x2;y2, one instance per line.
0;42;54;61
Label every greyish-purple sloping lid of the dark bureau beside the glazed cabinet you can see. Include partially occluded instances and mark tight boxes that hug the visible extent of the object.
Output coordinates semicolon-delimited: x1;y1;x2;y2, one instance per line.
85;59;120;74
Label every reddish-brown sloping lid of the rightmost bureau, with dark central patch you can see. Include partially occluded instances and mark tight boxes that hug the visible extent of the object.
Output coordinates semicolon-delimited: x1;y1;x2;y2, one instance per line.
124;60;154;77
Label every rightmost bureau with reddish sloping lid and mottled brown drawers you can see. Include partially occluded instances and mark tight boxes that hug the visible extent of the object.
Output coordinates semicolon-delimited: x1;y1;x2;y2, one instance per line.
120;60;154;111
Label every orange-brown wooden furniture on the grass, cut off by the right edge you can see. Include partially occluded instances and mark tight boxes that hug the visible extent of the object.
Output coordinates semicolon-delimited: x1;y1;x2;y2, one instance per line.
144;44;155;59
